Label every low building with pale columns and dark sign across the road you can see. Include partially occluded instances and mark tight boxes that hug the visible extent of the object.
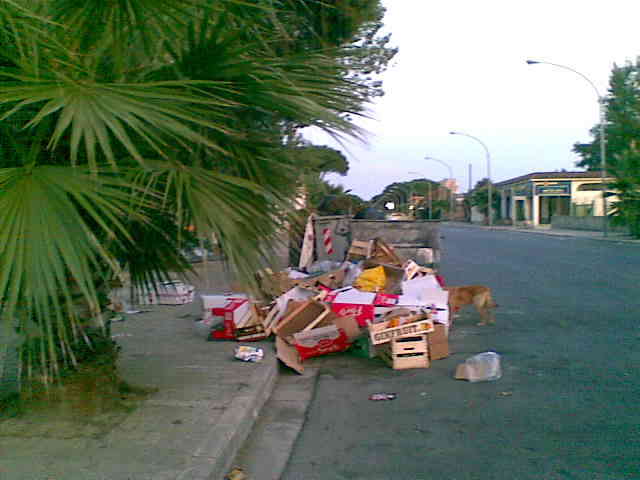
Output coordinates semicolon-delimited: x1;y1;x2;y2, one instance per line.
494;172;616;226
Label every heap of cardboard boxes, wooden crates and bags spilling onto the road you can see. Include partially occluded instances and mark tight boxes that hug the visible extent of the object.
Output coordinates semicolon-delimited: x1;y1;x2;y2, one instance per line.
196;239;451;373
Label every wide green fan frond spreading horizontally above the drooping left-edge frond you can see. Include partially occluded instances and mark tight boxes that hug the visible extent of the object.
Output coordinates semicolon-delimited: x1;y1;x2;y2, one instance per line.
0;82;238;169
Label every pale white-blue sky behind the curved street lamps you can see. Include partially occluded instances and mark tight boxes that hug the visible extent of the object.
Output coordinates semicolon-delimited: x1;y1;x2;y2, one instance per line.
305;0;640;199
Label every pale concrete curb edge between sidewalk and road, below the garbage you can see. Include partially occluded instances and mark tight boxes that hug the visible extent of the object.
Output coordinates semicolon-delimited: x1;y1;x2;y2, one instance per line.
176;344;278;480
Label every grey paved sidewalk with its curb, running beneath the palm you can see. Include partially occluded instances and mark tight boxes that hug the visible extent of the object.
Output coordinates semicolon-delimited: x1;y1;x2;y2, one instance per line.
0;262;278;480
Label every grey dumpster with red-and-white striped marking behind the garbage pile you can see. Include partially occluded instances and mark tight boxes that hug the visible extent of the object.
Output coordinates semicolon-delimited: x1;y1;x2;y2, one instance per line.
314;215;440;263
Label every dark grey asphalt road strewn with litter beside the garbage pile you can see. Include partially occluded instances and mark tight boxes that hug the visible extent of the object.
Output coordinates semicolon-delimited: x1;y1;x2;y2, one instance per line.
282;227;640;480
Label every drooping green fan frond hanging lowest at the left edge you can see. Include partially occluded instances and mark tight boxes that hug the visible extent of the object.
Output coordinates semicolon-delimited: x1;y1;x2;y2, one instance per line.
0;166;142;373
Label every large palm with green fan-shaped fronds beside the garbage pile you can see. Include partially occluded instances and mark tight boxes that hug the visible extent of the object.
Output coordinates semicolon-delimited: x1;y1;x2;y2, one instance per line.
0;0;388;386
